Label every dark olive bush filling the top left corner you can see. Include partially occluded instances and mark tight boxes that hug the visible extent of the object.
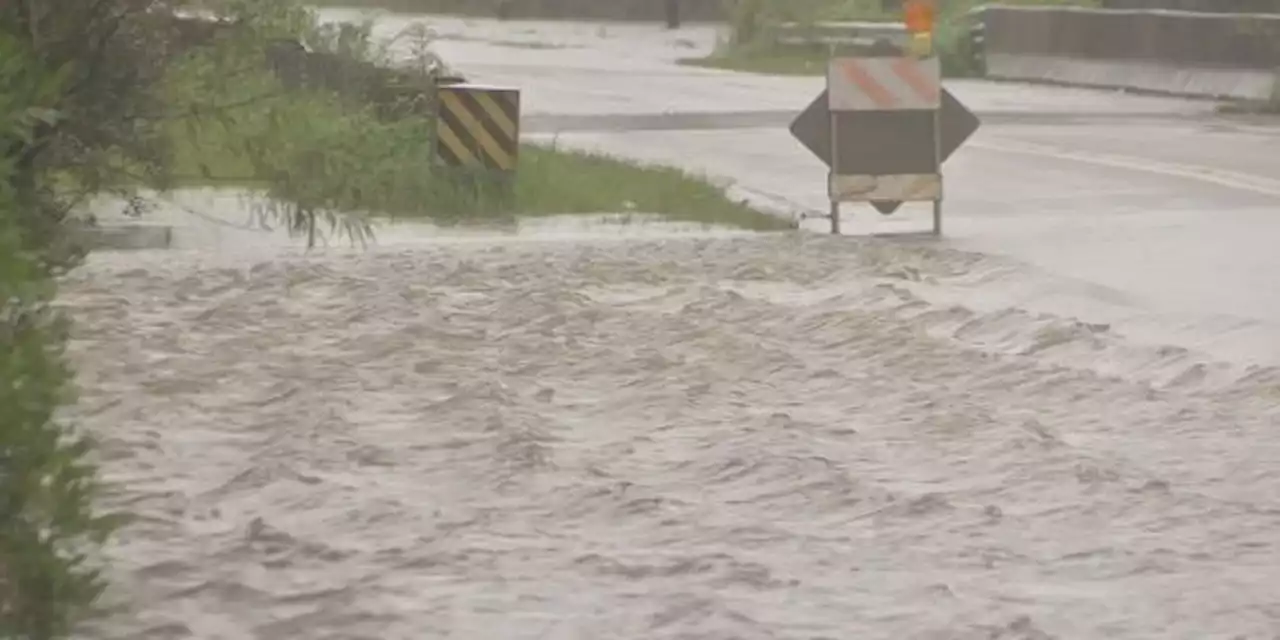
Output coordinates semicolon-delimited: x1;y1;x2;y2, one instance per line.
0;0;185;271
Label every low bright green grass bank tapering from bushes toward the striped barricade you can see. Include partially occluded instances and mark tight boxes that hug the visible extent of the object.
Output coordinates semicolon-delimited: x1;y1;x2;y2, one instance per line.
167;102;788;230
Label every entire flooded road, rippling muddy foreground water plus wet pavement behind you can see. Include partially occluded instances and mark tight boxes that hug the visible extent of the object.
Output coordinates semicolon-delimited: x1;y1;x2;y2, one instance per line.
77;12;1280;640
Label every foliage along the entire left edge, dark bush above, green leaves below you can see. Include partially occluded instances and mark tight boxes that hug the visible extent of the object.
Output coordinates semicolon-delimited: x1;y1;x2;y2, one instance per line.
0;0;168;632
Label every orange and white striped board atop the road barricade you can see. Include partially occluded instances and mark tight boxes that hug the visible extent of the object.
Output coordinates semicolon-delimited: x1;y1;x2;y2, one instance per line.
827;58;942;111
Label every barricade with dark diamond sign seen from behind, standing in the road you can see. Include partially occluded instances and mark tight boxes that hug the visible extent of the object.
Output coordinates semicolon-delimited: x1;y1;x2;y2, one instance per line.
791;54;980;232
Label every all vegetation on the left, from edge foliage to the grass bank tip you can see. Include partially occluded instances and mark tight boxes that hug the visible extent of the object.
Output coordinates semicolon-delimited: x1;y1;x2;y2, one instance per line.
0;0;785;640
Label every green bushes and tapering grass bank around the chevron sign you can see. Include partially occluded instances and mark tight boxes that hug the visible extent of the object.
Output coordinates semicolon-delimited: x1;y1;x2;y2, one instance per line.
157;3;787;232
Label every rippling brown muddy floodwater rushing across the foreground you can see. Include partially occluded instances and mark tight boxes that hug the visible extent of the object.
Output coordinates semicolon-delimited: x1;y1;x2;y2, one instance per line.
65;234;1280;640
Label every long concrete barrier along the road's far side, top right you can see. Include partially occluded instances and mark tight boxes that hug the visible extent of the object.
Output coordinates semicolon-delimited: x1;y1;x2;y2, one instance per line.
979;5;1280;101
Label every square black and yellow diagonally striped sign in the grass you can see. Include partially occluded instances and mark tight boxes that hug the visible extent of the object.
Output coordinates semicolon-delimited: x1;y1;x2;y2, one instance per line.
435;84;520;172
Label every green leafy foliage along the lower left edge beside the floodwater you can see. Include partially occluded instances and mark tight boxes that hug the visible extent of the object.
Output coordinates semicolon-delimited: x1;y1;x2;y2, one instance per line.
0;107;119;640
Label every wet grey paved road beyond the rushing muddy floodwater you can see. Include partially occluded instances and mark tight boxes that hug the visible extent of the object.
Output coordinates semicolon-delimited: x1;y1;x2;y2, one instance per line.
332;12;1280;371
